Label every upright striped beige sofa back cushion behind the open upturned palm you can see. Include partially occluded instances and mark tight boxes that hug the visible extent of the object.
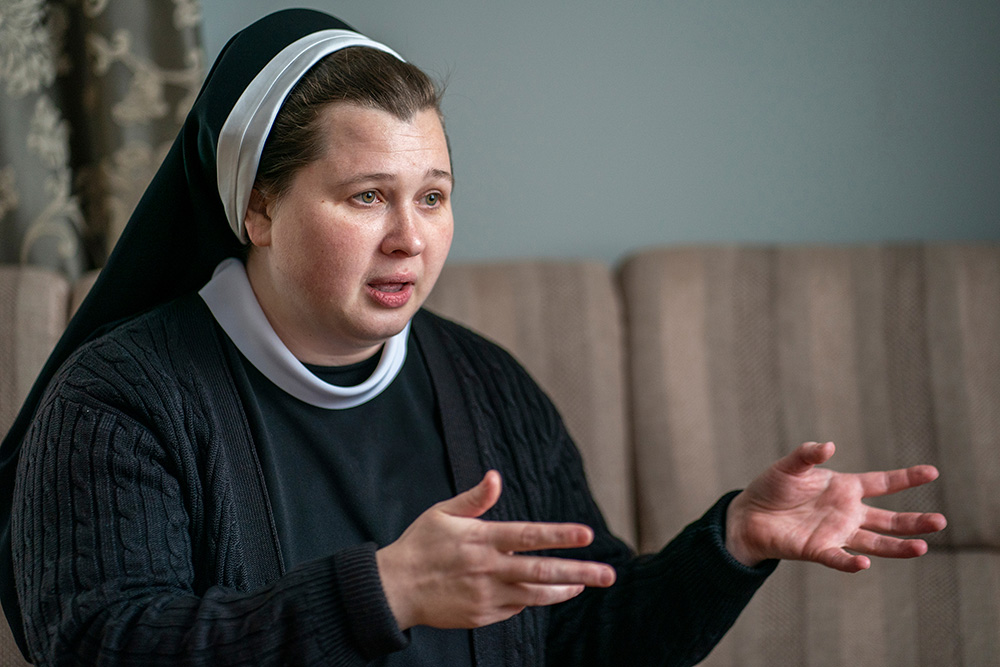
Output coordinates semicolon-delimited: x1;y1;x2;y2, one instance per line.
621;245;1000;549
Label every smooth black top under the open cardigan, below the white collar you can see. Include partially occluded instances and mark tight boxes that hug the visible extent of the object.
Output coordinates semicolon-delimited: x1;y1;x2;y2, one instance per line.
236;343;473;666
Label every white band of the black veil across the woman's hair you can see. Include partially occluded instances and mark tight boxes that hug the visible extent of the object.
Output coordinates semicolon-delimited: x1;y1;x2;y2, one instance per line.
216;30;402;243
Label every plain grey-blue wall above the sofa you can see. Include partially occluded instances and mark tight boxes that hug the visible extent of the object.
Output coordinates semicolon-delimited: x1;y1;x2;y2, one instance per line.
202;0;1000;261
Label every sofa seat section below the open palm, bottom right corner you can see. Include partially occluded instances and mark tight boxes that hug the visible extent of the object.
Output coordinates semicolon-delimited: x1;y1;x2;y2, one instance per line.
702;548;1000;667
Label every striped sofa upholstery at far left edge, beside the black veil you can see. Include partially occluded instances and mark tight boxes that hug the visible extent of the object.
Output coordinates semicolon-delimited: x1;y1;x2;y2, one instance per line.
0;266;69;667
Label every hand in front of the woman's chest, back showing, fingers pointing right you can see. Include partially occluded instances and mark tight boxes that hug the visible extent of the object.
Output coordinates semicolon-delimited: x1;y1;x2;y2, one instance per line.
375;470;615;630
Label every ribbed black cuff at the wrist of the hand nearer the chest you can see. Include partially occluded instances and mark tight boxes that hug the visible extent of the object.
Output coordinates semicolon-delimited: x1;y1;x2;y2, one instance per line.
334;543;410;660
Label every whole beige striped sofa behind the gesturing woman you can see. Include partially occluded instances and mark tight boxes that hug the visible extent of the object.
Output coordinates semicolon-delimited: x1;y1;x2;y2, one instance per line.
0;244;1000;667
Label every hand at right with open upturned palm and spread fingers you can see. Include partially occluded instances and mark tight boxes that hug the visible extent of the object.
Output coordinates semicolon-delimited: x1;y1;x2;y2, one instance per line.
726;442;947;572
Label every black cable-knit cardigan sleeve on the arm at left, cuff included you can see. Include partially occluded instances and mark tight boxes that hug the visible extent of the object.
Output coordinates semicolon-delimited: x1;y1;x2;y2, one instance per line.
12;310;407;666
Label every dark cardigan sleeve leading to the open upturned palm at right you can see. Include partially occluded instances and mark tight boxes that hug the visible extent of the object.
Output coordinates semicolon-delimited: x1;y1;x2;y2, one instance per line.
547;426;777;667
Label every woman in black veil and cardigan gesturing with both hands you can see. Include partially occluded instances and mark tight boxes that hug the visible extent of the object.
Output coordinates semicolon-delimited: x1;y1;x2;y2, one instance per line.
3;10;943;665
